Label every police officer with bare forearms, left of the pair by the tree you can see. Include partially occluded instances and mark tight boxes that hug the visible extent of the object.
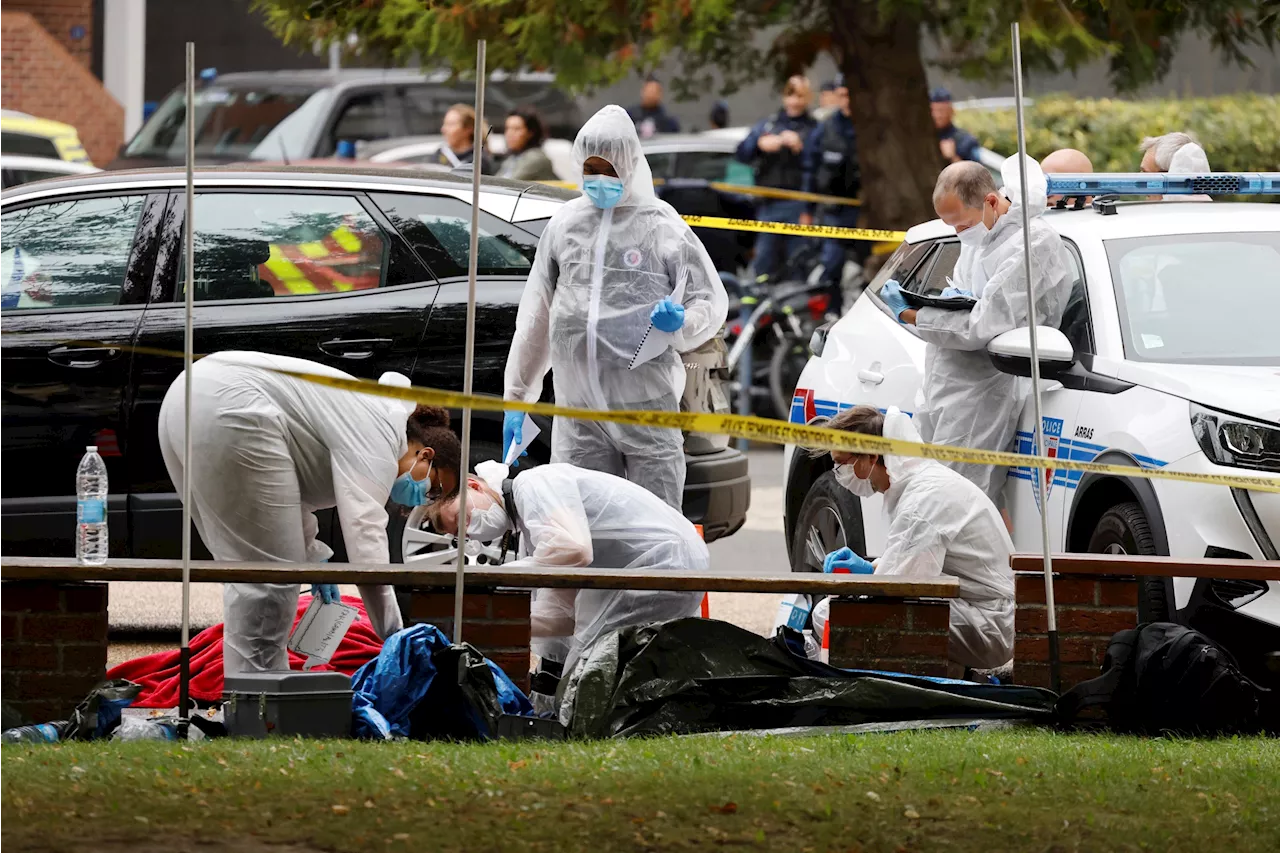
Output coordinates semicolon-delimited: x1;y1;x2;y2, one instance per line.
735;74;817;277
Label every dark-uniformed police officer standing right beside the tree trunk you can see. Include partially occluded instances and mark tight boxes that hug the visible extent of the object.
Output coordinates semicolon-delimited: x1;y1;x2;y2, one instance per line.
803;74;869;314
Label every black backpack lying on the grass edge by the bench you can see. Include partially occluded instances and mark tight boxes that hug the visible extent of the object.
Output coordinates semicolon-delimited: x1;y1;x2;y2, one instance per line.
1055;622;1271;734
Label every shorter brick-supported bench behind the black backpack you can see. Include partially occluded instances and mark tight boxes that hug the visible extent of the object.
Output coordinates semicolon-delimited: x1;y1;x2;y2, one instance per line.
1012;553;1280;688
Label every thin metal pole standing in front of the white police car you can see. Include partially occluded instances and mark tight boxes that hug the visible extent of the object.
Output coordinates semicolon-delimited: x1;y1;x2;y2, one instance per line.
1012;22;1062;693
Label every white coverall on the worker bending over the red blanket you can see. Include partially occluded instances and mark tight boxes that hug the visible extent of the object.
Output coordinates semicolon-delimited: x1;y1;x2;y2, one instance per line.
159;352;413;674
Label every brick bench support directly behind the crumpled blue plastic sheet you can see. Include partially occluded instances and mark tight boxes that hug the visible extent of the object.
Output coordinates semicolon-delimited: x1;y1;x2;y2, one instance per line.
408;588;530;693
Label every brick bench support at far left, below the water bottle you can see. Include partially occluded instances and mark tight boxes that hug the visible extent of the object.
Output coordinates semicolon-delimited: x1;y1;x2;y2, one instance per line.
0;581;106;722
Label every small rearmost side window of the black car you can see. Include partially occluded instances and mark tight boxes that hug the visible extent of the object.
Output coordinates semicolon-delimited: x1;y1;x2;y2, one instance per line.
374;193;538;278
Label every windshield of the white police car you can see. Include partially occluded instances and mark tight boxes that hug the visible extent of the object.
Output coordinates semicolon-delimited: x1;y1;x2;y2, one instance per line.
1105;232;1280;366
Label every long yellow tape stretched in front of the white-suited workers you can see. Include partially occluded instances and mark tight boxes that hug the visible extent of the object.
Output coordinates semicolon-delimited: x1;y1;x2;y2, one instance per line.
264;370;1280;494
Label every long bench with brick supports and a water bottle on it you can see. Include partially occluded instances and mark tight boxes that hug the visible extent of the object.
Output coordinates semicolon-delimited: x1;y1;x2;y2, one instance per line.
0;557;959;721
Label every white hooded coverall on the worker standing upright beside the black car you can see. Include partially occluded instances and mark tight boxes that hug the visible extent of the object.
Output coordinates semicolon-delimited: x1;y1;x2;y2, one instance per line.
504;105;728;510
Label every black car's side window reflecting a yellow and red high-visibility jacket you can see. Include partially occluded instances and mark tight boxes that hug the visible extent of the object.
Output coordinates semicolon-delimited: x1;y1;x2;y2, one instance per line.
185;192;388;300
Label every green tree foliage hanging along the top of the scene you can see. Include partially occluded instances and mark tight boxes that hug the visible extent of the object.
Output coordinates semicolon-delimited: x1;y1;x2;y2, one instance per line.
255;0;1280;93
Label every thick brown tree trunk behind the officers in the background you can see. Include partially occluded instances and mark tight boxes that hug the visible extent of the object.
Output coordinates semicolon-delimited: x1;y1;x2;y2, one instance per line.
828;0;942;229
